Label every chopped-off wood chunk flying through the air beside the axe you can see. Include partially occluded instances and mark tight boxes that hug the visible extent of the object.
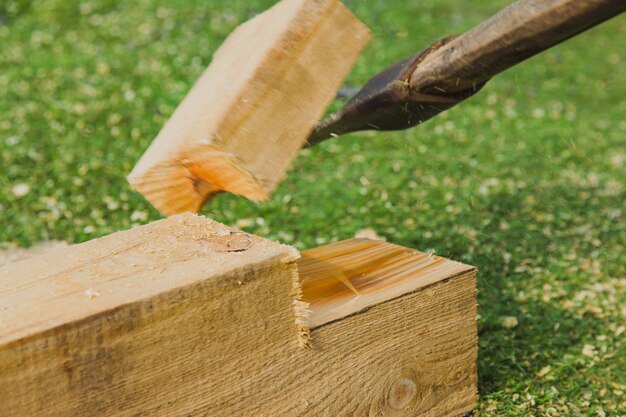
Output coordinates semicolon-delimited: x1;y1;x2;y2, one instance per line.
129;0;369;215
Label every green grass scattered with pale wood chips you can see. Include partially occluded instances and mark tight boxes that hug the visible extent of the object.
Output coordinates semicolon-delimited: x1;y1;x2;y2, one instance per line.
0;0;626;416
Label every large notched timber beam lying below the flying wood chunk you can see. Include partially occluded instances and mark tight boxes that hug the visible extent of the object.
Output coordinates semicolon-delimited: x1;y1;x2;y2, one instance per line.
0;219;477;417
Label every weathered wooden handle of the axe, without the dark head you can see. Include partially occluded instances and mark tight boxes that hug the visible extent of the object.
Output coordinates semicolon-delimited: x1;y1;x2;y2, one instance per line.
410;0;626;93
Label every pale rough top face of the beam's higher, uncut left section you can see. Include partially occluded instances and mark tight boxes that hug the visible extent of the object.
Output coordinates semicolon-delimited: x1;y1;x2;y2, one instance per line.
0;213;299;346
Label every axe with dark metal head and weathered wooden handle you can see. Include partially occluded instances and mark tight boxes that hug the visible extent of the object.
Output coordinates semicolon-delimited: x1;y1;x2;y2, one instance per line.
307;0;626;146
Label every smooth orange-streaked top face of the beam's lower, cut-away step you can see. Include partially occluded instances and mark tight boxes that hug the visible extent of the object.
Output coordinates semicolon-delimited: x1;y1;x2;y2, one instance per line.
298;239;476;330
